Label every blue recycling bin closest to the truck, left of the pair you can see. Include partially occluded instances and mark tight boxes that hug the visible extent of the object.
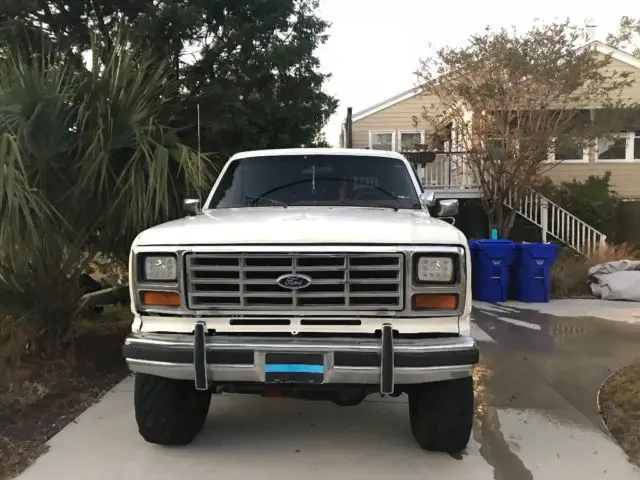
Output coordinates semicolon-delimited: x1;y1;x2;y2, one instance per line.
472;240;515;303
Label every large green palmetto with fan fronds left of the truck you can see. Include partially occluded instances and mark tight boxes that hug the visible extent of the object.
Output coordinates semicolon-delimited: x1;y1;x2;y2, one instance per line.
0;36;213;356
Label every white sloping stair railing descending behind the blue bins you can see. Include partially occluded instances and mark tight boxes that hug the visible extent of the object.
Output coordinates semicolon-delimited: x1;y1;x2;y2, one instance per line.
505;192;607;256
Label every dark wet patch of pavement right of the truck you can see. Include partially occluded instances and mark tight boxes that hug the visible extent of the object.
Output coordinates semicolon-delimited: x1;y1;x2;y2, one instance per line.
473;302;640;427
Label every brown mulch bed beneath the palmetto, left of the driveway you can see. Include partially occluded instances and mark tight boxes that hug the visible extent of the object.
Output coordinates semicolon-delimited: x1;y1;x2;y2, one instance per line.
0;332;127;480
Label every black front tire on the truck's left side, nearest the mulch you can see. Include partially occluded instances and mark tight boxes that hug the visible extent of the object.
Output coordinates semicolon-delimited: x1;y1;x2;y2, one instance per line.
134;373;211;445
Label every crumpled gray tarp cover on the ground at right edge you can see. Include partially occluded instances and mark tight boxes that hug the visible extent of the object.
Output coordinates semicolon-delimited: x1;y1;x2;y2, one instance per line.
589;260;640;302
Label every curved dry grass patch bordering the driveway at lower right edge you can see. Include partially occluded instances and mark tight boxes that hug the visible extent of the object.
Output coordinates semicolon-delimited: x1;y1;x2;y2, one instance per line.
600;360;640;465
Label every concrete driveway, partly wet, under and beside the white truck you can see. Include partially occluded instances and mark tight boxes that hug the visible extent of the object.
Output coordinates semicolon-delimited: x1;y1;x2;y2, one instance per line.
19;300;640;480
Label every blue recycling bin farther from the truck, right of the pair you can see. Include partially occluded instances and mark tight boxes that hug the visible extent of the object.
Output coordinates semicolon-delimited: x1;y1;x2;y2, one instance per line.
515;243;558;303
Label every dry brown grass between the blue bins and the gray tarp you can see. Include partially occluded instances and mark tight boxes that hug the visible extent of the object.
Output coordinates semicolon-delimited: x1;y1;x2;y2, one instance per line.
551;243;640;298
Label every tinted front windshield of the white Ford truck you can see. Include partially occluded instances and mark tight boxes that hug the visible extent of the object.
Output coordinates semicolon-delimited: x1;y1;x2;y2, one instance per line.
208;155;420;209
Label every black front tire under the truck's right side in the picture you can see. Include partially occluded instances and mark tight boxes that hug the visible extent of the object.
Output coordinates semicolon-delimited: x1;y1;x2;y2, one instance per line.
409;377;473;453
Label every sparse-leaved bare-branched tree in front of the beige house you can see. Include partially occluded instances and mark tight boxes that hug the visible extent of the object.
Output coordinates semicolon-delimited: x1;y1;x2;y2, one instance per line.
416;22;638;237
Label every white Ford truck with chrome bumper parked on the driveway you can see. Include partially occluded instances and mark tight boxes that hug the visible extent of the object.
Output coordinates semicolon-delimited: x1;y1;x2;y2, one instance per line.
123;149;478;452
